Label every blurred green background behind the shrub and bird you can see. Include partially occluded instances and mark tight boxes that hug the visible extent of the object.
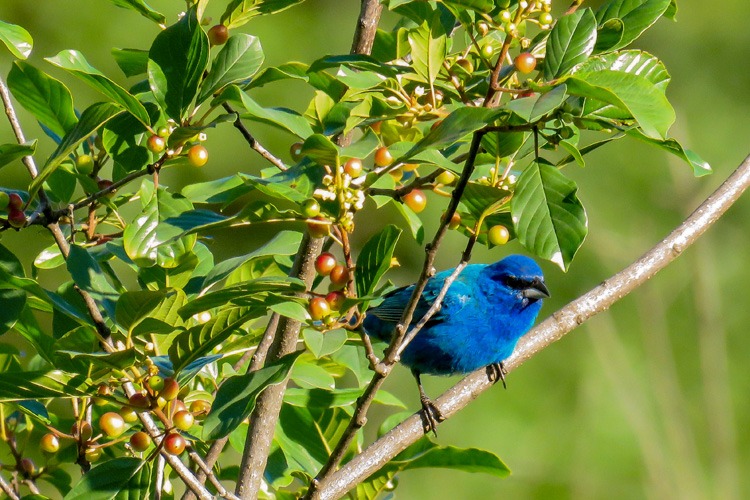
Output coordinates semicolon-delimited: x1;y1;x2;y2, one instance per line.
0;0;750;499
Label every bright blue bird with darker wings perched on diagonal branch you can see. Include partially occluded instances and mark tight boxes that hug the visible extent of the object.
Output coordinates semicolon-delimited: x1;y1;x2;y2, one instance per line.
363;255;549;432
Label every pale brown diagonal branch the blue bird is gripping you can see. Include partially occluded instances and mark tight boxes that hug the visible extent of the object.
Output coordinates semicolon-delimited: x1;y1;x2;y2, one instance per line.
312;152;750;499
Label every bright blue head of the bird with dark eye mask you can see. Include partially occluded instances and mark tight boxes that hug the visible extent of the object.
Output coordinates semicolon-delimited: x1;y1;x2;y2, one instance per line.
484;255;550;306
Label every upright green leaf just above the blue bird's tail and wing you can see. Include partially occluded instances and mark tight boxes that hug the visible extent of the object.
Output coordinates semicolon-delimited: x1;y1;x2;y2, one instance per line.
354;224;401;304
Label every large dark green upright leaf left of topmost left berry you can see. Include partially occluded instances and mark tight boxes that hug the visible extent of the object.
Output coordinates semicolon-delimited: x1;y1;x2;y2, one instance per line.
148;10;209;123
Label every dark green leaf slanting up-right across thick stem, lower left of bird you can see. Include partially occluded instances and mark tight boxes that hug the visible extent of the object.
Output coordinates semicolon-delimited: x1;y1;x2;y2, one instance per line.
202;351;303;440
